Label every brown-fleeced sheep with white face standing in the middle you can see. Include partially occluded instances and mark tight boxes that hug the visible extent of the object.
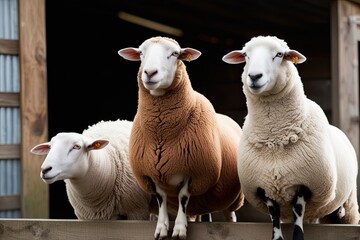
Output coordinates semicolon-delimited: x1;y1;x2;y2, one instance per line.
118;37;244;239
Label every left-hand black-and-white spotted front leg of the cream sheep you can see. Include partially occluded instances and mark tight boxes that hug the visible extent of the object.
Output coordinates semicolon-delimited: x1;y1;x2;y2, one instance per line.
257;188;284;240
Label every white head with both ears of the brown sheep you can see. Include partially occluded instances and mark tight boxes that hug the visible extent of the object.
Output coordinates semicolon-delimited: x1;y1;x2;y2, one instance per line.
118;37;201;96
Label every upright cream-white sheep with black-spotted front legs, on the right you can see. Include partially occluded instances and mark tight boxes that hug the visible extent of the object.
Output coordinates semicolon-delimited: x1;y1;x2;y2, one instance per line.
223;36;359;239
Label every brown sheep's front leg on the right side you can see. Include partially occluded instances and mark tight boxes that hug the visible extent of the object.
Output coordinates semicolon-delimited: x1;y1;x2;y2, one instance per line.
172;179;190;239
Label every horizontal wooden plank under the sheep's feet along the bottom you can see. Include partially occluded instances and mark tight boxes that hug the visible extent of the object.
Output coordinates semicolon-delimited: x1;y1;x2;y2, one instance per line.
0;219;360;240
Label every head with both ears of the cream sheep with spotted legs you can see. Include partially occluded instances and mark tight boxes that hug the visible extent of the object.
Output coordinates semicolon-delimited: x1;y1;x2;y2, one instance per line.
222;36;306;95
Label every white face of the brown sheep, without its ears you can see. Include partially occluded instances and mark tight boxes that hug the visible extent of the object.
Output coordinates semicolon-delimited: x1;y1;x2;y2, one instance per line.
139;41;181;96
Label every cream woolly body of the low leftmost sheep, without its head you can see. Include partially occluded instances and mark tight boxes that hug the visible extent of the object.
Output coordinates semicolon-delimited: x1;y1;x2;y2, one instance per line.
65;120;151;220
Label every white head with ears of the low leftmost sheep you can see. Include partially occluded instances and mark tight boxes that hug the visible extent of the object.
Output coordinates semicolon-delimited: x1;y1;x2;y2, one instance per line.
30;133;109;184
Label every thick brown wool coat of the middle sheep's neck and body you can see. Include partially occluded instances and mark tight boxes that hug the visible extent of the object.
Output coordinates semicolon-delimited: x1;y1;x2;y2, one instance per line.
129;60;244;215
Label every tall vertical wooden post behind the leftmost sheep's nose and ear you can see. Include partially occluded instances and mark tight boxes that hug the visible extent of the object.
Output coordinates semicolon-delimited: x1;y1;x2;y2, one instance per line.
18;0;49;218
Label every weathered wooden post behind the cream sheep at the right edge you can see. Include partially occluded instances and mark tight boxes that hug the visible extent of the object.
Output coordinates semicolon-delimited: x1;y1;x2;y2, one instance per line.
331;0;360;158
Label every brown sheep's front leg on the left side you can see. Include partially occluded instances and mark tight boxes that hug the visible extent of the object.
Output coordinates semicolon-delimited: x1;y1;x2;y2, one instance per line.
154;186;169;239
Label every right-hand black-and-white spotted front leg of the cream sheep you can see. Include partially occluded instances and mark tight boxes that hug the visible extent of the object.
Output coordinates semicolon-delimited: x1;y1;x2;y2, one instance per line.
293;186;311;240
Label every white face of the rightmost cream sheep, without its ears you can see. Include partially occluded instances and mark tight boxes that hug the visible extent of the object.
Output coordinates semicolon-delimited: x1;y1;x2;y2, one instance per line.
244;46;285;94
